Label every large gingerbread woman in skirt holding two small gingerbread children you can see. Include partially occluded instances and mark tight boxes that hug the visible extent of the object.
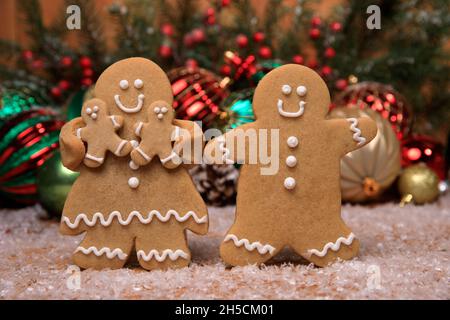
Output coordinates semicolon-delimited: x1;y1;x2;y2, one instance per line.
60;58;208;270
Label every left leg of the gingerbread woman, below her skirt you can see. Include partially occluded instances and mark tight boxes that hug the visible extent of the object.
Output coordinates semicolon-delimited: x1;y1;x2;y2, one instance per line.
72;221;133;269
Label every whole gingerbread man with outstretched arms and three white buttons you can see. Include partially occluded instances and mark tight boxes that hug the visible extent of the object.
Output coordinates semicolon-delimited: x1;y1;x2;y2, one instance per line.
205;65;377;266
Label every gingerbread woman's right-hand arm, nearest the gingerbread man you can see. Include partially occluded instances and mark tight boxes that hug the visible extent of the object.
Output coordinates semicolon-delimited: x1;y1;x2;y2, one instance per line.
172;119;205;164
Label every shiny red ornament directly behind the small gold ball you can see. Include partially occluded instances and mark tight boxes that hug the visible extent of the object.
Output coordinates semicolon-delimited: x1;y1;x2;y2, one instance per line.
402;135;446;180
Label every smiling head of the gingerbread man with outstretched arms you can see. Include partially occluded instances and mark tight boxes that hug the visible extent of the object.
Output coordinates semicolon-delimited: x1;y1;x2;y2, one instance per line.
253;64;330;124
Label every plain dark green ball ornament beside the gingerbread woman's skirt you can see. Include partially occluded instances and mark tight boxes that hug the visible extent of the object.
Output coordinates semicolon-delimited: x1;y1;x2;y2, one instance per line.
36;151;79;216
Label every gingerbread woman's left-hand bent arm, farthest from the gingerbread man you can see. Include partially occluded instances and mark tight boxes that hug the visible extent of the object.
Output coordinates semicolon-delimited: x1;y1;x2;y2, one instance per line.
59;117;86;171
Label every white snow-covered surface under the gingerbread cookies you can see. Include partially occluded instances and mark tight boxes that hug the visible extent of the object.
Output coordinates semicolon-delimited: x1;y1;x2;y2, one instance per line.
0;195;450;299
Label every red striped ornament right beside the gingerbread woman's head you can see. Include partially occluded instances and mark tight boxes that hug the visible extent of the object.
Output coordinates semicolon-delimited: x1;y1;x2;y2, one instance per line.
167;67;229;126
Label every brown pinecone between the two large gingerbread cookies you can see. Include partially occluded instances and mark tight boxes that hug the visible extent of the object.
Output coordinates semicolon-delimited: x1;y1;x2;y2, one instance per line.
189;164;239;206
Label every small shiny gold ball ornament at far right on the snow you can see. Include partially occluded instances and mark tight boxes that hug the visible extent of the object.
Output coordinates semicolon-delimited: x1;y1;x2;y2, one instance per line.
398;163;440;207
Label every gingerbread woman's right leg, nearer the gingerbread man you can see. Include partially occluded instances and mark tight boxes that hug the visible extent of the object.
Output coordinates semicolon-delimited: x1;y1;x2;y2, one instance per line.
136;220;191;270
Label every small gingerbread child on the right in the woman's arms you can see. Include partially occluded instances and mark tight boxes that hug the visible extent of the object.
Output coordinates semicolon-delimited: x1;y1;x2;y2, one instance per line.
131;101;181;169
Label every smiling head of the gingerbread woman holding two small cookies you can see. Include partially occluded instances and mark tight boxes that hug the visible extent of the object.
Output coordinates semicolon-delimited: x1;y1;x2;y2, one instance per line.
95;58;173;119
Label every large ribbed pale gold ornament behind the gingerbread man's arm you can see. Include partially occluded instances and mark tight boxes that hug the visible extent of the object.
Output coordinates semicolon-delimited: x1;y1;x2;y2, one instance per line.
329;107;401;202
